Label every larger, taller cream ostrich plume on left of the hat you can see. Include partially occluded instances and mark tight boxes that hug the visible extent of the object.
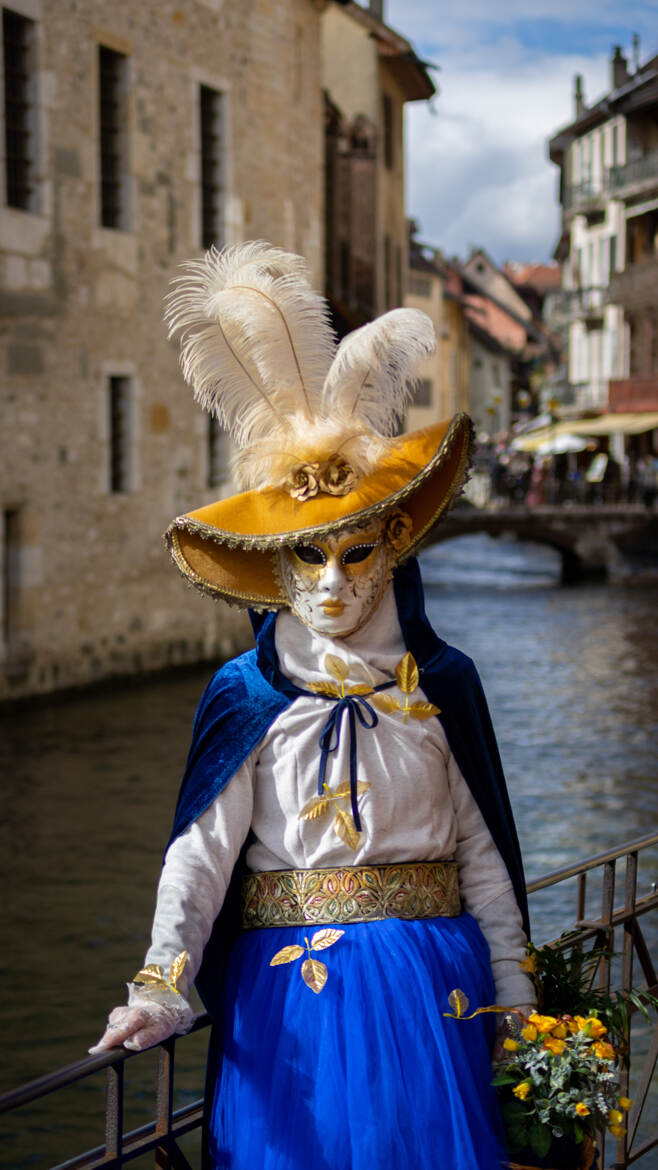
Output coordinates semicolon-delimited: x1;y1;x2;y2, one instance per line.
165;241;335;447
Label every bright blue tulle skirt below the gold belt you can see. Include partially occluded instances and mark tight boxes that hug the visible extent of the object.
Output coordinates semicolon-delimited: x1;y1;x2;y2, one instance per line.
208;914;505;1170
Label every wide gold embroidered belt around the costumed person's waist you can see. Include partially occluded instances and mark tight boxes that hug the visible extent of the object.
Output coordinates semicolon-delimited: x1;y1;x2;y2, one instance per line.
237;861;461;930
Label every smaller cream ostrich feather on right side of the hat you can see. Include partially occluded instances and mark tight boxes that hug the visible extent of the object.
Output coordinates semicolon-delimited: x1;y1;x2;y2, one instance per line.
323;309;437;435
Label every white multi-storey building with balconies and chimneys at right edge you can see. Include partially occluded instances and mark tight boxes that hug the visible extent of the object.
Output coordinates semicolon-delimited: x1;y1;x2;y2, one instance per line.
549;46;658;425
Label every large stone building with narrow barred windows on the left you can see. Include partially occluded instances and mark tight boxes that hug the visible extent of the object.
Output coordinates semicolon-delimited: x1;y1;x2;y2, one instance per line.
0;0;323;698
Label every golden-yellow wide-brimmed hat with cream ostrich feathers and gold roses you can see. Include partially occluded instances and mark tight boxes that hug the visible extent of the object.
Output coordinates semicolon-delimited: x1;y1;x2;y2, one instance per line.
165;242;473;608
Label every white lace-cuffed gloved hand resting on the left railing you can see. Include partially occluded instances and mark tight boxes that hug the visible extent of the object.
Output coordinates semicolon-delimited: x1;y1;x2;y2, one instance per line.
89;983;196;1057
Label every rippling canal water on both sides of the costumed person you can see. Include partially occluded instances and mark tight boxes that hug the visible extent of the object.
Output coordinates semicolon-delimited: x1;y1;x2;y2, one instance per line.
0;536;658;1170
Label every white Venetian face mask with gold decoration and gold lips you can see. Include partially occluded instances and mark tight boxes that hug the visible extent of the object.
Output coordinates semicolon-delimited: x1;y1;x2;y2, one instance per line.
280;522;393;638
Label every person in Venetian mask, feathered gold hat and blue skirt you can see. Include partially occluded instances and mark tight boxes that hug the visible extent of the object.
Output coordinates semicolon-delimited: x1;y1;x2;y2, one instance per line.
94;243;532;1170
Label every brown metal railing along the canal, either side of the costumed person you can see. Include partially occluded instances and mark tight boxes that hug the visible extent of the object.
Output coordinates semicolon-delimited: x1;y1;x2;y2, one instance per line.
0;833;658;1170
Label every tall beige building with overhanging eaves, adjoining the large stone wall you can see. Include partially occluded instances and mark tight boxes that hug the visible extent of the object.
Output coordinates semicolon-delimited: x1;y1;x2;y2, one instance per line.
322;0;434;331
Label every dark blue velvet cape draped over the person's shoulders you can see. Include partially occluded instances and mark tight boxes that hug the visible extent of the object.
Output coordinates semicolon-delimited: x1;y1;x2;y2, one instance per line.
171;560;529;1019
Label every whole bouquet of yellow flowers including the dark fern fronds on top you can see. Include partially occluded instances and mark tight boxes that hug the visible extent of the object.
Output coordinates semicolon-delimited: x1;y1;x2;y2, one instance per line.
445;934;658;1170
